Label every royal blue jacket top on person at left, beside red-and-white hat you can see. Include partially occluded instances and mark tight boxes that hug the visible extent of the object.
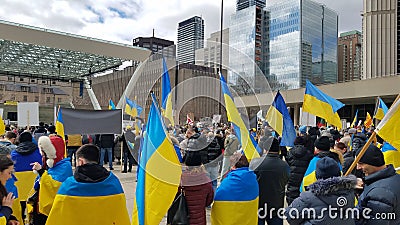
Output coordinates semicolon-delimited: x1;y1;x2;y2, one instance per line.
11;142;42;172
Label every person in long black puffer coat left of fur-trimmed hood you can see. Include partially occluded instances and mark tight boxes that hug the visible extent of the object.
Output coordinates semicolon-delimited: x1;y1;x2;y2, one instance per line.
286;136;313;205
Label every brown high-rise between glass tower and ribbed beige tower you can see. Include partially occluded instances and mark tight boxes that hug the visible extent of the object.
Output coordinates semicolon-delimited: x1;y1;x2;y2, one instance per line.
338;30;362;82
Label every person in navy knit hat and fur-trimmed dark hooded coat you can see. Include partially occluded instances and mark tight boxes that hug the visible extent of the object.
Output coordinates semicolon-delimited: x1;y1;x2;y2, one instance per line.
285;157;357;225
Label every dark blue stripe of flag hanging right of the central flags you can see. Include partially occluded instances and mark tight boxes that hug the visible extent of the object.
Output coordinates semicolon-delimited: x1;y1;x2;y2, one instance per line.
272;91;296;147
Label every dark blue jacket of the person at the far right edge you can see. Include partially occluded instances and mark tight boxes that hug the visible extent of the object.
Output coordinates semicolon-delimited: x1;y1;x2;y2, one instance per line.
356;165;400;225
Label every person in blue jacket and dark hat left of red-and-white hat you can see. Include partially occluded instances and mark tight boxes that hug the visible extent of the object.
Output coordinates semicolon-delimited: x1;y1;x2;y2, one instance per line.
11;131;42;222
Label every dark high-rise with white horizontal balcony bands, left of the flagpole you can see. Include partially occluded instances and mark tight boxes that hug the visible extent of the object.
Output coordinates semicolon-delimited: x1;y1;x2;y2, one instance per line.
178;16;204;64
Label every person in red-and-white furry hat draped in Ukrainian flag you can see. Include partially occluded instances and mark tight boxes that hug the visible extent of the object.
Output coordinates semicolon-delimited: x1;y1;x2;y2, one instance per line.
28;135;72;225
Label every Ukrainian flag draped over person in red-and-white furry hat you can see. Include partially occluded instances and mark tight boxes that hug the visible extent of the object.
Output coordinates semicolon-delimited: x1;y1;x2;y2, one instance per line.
39;158;72;216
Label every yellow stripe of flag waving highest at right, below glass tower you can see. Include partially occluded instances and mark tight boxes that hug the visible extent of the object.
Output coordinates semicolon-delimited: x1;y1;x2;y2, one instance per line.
303;95;342;129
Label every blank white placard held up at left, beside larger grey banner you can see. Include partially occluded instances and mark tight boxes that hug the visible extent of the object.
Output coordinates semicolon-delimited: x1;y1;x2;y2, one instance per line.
17;102;39;127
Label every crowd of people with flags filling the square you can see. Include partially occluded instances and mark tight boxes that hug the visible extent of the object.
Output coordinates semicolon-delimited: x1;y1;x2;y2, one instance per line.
0;123;400;225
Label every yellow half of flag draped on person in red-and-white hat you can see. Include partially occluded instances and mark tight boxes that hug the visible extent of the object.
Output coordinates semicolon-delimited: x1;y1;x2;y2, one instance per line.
39;171;61;216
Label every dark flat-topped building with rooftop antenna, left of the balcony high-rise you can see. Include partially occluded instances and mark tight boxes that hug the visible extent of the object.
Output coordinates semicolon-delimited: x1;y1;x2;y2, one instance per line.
133;35;176;58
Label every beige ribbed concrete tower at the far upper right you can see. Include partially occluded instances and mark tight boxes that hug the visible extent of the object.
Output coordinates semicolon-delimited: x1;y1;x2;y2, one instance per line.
362;0;400;79
